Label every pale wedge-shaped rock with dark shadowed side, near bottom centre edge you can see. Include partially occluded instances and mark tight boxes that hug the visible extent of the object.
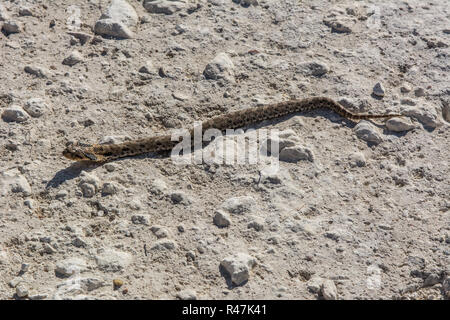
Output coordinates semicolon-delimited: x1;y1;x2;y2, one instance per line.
220;253;256;286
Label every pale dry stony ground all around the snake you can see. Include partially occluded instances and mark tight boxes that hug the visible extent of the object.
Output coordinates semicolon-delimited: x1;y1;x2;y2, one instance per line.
0;0;450;299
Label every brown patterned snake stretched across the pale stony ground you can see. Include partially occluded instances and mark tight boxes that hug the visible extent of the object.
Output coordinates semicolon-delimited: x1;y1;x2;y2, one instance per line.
63;97;402;162
